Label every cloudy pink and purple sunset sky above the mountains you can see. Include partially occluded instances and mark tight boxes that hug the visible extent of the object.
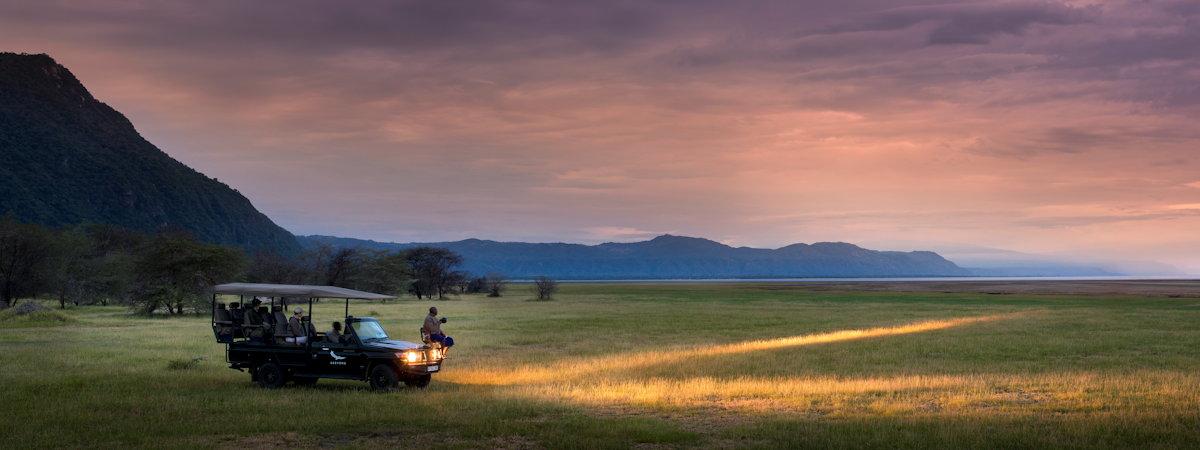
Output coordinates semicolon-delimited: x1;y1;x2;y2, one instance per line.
0;0;1200;274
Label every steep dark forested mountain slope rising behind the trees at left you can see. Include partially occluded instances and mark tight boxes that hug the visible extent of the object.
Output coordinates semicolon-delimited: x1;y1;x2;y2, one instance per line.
0;53;300;253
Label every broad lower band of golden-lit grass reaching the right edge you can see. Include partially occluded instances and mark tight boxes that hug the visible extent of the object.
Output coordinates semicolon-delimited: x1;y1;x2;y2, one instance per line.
511;371;1200;416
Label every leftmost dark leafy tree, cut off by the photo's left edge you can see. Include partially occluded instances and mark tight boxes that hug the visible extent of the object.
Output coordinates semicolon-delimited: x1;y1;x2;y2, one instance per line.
0;217;53;308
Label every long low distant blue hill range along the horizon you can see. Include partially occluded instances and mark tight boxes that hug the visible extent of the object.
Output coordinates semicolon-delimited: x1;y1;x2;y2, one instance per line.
296;234;972;280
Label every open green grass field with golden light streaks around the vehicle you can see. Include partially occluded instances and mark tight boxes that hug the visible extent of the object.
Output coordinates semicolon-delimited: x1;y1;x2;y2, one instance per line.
0;284;1200;448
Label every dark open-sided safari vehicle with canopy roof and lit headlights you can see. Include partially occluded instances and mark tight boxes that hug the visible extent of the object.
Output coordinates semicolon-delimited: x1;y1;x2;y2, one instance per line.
212;283;445;390
